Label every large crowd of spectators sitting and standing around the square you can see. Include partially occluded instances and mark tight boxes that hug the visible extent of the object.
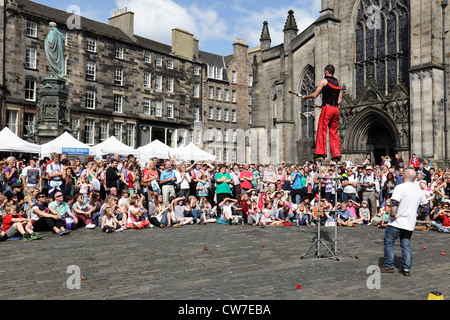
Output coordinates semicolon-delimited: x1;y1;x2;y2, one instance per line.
0;154;450;241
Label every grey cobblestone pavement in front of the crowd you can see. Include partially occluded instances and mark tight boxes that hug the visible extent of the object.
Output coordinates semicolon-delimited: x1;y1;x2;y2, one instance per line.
0;223;450;301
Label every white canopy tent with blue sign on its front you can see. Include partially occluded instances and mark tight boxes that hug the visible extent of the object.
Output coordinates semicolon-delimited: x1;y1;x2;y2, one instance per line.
41;132;95;157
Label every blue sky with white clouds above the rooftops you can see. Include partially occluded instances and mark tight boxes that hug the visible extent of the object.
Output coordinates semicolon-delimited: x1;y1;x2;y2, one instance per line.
34;0;321;55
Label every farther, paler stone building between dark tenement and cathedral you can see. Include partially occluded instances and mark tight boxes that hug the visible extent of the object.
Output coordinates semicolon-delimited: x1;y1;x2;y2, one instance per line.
199;39;253;163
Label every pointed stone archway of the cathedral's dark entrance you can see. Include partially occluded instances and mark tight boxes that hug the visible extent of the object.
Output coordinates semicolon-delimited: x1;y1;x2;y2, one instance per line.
343;107;400;164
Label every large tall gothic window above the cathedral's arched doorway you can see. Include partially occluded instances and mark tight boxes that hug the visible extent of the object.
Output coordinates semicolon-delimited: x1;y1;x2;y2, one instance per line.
355;0;409;94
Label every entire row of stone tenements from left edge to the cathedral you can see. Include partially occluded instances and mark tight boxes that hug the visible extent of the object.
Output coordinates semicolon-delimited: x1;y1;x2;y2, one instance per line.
0;0;251;162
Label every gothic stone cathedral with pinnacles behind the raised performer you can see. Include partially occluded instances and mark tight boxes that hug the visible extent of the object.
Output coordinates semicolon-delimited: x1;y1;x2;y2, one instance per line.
251;0;450;165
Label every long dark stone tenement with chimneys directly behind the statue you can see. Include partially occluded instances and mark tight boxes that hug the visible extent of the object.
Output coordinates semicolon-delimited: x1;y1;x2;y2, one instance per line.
1;0;202;147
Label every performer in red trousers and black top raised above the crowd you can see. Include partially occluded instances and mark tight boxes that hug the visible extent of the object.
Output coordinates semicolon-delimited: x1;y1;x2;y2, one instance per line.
302;65;342;161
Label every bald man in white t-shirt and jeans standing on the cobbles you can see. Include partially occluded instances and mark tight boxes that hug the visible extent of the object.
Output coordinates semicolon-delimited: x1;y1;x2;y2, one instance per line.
380;169;427;276
